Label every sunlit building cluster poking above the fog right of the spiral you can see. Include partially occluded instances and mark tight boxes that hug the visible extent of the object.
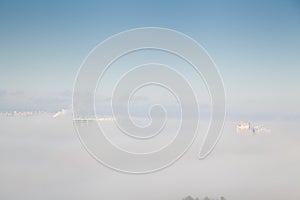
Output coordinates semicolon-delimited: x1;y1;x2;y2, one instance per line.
236;122;271;135
